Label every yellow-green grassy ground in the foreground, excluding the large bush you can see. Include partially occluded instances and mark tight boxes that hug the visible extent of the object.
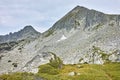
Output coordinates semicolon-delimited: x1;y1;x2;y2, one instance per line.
0;63;120;80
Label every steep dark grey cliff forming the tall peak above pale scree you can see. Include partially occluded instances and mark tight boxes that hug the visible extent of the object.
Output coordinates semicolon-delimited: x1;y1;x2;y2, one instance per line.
52;6;120;30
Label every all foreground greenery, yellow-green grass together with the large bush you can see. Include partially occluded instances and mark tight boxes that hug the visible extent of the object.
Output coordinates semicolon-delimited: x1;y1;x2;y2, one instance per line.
0;53;120;80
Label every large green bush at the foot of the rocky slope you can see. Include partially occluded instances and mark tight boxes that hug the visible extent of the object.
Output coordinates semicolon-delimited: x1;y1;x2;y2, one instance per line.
38;52;63;75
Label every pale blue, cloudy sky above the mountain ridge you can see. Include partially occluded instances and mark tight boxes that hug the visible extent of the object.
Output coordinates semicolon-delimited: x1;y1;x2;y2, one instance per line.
0;0;120;35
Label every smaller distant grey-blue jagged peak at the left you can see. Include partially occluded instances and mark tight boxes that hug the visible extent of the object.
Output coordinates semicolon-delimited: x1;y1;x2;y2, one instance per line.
0;26;40;43
